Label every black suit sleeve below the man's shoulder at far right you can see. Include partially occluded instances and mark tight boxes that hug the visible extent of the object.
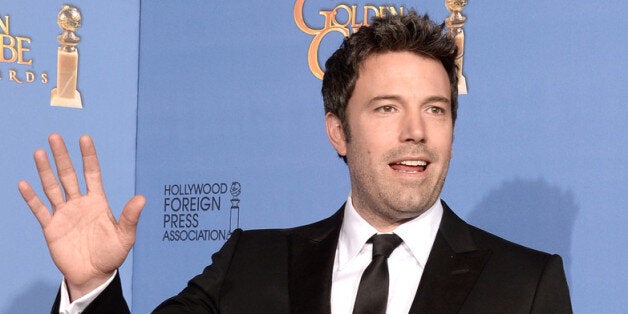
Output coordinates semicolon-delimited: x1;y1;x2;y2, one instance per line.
531;255;573;314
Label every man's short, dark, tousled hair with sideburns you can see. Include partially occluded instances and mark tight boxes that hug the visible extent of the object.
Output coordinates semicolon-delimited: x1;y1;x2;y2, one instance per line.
321;11;458;140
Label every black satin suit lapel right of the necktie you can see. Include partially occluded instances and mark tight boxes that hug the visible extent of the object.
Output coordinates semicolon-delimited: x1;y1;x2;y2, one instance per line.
410;202;491;313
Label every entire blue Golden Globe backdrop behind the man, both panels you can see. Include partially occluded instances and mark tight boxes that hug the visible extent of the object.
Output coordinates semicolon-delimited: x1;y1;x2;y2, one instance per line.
0;0;628;313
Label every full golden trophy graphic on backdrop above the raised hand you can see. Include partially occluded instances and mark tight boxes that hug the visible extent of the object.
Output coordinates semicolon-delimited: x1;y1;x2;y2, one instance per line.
50;4;83;108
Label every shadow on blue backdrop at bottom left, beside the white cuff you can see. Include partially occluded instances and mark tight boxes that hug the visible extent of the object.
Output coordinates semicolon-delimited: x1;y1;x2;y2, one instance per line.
5;279;59;314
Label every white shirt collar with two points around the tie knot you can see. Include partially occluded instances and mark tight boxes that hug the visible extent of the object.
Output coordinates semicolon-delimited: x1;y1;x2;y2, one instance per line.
337;196;443;268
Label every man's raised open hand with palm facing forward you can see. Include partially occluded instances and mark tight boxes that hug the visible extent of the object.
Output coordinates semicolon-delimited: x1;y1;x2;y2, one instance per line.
18;134;146;300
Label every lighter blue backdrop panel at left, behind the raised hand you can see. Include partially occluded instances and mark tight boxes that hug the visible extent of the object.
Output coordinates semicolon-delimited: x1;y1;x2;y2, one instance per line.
0;0;140;313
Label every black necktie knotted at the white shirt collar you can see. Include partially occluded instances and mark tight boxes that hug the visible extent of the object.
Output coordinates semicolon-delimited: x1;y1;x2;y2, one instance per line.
353;234;402;314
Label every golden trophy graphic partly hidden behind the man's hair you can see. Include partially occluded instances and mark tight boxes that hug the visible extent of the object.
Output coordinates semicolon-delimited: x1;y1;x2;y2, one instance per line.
445;0;467;94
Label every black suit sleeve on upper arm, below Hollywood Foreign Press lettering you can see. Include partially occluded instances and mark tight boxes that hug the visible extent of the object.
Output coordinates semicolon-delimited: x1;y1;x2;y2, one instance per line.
153;229;242;314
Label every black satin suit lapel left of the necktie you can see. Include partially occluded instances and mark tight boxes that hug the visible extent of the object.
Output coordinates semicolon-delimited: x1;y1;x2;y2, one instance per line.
288;206;344;313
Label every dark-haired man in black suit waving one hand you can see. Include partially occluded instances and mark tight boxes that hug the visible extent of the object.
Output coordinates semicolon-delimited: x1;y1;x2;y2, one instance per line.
19;12;571;313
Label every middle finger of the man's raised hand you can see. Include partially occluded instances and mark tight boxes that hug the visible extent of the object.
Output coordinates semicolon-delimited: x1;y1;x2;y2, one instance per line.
48;133;81;199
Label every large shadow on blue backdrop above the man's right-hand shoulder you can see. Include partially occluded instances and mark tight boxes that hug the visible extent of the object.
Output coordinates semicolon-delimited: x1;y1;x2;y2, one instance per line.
467;178;578;282
